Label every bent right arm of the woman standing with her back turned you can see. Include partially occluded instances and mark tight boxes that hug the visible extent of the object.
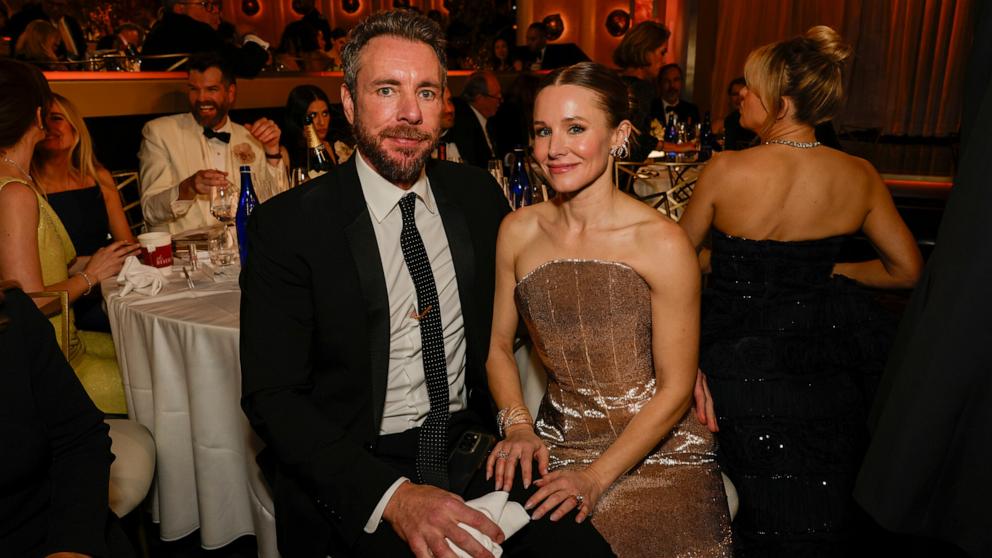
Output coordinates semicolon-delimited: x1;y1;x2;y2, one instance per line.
833;162;923;289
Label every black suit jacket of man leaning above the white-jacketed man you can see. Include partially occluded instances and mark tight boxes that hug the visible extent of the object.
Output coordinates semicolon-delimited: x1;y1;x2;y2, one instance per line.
141;12;269;77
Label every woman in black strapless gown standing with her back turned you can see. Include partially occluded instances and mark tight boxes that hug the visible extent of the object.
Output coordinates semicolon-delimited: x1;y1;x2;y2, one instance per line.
681;26;921;558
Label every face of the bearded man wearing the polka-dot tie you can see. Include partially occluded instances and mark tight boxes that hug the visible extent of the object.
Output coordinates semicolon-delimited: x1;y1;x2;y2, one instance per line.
341;35;444;187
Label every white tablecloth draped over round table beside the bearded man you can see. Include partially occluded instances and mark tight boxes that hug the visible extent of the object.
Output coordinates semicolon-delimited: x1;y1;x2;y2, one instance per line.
103;272;278;558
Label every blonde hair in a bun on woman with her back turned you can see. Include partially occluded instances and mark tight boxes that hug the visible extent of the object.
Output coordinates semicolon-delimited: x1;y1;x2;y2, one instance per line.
744;25;852;136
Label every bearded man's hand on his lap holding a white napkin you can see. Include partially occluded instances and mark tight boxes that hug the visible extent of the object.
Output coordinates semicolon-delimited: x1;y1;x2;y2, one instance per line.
382;482;504;558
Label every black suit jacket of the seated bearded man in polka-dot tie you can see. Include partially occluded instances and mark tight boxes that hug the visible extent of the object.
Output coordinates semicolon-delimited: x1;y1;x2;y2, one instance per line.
241;157;508;557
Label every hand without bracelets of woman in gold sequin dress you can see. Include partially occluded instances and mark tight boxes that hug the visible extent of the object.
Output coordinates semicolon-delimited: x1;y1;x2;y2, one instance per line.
524;468;604;523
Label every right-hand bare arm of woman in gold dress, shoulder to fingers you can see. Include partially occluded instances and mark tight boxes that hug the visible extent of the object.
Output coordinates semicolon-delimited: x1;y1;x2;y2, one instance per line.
528;223;700;521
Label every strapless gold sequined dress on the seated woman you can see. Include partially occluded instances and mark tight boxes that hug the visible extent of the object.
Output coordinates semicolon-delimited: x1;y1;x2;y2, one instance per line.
515;260;731;558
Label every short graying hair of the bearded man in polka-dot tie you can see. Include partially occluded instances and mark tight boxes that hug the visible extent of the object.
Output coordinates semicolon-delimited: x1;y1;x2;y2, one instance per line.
341;10;448;96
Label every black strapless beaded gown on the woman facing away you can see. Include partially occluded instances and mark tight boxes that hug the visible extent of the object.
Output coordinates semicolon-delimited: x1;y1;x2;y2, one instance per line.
700;229;893;558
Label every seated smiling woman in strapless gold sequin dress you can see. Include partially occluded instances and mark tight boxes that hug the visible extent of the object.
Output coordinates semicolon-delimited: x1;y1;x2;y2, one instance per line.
487;63;730;557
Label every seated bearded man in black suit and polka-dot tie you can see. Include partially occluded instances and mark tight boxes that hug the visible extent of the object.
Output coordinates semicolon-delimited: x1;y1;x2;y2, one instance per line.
241;10;609;558
